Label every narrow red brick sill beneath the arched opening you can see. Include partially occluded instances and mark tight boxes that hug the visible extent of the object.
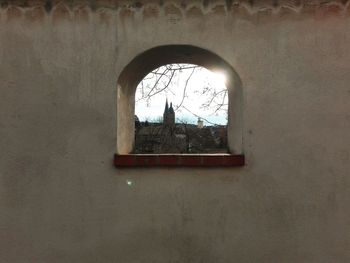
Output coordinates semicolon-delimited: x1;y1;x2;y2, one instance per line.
114;154;245;167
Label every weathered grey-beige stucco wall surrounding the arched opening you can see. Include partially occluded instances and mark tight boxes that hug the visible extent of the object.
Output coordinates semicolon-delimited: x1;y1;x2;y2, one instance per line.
0;0;350;263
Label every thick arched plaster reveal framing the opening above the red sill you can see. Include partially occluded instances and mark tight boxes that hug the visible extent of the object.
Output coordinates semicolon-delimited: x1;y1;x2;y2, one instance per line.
117;45;243;154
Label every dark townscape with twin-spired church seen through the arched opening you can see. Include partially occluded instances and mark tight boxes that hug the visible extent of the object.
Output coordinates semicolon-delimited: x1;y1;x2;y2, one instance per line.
134;100;227;153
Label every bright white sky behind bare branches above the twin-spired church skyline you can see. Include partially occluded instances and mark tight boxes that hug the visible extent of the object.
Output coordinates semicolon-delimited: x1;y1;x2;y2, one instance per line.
135;64;227;125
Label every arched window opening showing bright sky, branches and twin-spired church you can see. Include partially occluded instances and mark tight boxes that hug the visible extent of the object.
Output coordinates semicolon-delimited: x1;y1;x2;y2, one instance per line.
133;63;228;154
